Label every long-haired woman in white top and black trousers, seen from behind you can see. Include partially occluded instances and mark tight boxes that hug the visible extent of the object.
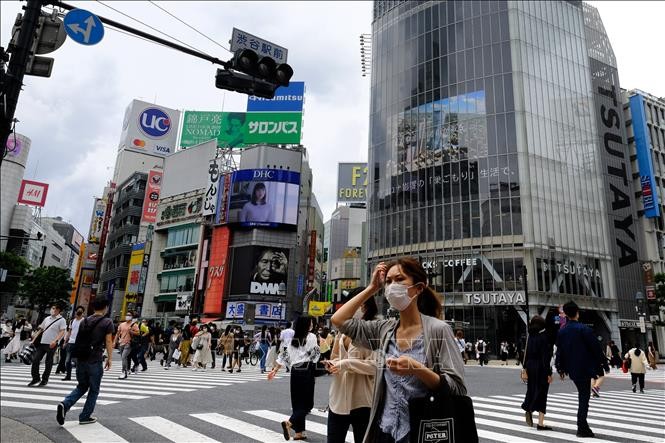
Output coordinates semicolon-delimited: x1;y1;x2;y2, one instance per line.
268;315;321;440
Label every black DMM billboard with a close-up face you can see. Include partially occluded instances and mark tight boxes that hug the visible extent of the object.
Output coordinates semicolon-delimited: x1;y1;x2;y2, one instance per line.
229;246;289;297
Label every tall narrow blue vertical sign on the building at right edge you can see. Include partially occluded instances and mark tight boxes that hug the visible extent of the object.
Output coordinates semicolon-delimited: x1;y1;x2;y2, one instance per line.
630;94;660;218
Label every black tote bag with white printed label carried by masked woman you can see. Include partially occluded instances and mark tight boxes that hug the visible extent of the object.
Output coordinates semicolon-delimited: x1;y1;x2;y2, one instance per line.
409;385;478;443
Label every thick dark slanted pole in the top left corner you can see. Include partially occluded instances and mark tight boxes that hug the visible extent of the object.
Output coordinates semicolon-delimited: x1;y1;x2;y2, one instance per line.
0;0;43;169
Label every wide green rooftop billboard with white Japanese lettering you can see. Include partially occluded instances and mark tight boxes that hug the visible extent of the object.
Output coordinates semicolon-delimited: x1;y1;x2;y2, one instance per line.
180;111;302;148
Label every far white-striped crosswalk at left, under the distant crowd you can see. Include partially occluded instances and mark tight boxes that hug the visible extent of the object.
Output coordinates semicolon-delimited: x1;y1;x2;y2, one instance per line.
0;361;283;410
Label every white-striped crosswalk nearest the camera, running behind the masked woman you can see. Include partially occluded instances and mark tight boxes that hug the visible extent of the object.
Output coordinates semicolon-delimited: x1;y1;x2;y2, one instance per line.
49;390;665;443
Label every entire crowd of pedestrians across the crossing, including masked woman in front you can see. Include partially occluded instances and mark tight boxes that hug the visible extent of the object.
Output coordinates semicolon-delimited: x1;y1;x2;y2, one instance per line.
0;258;659;443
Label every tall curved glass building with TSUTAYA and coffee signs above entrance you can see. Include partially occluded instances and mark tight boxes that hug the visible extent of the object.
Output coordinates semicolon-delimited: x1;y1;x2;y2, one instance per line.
368;1;639;349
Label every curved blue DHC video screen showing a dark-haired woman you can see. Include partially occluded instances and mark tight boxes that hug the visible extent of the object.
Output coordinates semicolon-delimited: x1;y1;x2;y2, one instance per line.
218;169;300;228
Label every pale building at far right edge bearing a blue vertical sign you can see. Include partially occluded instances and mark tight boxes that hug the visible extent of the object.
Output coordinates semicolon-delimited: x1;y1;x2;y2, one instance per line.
623;90;665;348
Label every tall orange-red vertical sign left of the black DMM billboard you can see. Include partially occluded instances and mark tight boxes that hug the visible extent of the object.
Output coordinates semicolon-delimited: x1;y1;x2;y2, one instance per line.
203;226;231;316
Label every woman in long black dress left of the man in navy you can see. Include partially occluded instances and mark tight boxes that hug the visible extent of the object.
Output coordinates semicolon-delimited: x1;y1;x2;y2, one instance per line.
522;315;552;431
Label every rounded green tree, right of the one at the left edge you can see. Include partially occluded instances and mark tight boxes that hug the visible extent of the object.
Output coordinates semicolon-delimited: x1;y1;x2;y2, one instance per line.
20;266;72;320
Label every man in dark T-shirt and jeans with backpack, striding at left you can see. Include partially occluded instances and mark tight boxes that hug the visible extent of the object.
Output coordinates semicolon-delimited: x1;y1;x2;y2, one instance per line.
56;297;113;425
